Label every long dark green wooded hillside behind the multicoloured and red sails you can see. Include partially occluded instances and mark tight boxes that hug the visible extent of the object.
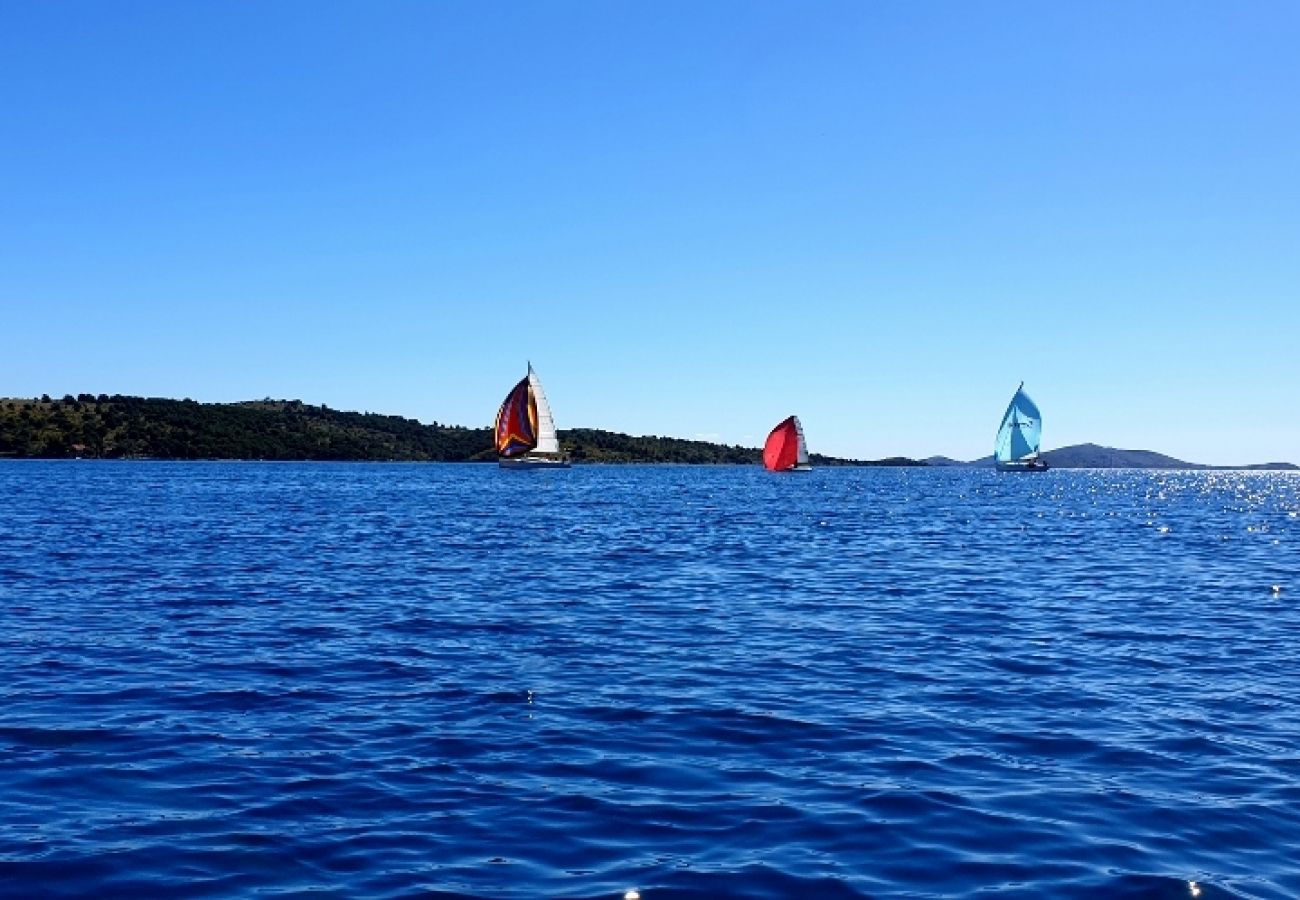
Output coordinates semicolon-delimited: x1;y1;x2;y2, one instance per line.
0;394;926;466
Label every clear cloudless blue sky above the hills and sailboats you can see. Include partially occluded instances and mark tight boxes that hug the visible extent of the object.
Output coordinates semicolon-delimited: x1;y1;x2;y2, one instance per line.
0;0;1300;464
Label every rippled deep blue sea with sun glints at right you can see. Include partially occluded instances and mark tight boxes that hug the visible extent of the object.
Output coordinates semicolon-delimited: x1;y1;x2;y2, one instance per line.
0;460;1300;900
